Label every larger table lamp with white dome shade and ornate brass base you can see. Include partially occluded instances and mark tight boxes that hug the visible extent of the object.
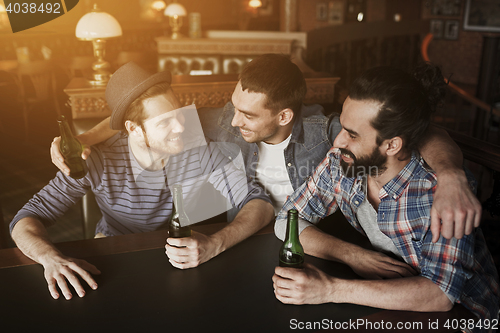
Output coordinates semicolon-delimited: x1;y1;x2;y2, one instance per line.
76;4;122;85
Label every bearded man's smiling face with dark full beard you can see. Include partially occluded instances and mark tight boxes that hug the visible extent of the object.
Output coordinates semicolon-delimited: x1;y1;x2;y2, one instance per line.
333;97;387;177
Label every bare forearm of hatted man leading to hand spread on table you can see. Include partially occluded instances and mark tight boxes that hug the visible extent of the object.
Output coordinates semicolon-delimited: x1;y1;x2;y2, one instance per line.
12;217;61;264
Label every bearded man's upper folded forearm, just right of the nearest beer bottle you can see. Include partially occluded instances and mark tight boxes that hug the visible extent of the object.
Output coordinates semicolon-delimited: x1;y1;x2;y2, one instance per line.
299;226;365;265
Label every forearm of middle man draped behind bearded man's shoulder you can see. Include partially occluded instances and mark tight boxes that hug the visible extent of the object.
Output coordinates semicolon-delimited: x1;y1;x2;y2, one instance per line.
419;126;465;178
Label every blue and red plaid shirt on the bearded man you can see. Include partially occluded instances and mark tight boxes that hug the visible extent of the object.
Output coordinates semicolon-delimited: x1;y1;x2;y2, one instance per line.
275;148;499;319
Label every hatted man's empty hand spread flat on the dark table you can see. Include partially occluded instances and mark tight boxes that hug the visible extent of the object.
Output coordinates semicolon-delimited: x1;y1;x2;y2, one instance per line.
40;256;101;300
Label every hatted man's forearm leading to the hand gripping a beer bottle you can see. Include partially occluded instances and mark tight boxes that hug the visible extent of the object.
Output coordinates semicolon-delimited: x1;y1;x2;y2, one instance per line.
211;199;274;254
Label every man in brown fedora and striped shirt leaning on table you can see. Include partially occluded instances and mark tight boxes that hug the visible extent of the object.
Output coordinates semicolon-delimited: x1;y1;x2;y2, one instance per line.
10;62;274;299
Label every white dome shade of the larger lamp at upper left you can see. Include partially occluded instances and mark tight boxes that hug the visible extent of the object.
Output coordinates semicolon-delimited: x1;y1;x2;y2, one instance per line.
76;11;122;40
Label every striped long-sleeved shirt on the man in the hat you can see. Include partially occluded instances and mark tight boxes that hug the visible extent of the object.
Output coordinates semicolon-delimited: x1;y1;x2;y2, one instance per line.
10;133;270;236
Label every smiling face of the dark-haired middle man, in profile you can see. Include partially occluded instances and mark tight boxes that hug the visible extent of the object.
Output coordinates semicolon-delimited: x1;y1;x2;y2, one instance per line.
231;82;287;144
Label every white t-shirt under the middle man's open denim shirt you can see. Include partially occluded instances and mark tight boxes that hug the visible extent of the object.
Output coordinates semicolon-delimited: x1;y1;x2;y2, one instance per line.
256;134;293;215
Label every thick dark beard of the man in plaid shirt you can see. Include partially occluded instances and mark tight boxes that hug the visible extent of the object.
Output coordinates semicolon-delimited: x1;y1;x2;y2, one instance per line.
339;146;387;178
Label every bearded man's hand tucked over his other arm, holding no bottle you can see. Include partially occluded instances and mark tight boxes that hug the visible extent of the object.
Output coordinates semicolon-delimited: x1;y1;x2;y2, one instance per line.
347;250;418;280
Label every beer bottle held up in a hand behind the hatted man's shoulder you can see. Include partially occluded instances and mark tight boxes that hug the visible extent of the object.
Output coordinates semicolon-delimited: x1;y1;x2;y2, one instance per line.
57;116;88;179
